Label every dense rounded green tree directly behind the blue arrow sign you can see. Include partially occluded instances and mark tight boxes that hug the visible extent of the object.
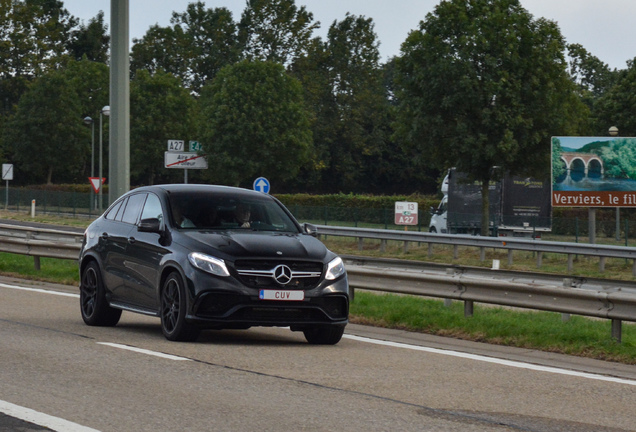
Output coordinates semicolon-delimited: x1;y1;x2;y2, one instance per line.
199;60;311;185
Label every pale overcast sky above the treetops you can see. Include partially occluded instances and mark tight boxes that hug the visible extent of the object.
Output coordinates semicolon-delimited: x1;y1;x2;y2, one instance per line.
63;0;636;69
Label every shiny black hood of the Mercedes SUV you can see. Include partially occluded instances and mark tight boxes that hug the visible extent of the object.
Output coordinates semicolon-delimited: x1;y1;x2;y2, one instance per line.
178;231;329;262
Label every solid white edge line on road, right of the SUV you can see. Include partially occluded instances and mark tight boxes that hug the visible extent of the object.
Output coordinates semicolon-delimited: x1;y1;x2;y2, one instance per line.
342;334;636;386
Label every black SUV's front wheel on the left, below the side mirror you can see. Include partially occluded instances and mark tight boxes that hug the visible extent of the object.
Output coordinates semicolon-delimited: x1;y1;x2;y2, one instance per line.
161;272;200;342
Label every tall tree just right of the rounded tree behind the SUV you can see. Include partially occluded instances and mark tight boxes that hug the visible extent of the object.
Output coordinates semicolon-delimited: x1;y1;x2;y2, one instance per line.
291;14;394;191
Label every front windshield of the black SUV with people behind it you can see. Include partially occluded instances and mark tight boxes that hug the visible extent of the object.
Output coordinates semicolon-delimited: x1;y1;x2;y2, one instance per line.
170;191;299;233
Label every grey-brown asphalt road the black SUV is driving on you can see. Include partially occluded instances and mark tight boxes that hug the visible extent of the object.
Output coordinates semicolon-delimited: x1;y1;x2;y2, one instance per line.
0;278;636;432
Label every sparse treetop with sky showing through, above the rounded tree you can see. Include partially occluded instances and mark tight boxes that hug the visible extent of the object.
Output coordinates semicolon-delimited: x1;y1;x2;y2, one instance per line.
239;0;320;65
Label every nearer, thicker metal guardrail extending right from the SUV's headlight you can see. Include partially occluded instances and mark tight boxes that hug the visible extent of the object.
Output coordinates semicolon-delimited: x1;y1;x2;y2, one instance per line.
344;256;636;341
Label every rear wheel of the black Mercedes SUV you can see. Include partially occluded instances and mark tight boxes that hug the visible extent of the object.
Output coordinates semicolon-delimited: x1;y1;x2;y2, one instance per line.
80;261;121;327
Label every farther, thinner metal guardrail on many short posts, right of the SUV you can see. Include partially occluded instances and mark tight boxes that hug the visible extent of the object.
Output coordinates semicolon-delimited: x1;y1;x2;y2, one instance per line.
317;225;636;276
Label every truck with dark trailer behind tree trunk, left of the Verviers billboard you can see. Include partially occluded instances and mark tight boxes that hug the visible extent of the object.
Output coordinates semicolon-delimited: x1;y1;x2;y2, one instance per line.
429;168;552;238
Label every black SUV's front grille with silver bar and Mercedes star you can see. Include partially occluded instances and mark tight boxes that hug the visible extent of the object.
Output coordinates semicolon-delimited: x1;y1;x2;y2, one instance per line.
234;260;323;290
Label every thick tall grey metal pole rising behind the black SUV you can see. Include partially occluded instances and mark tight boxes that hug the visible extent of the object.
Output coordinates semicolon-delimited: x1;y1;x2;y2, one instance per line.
108;0;130;203
